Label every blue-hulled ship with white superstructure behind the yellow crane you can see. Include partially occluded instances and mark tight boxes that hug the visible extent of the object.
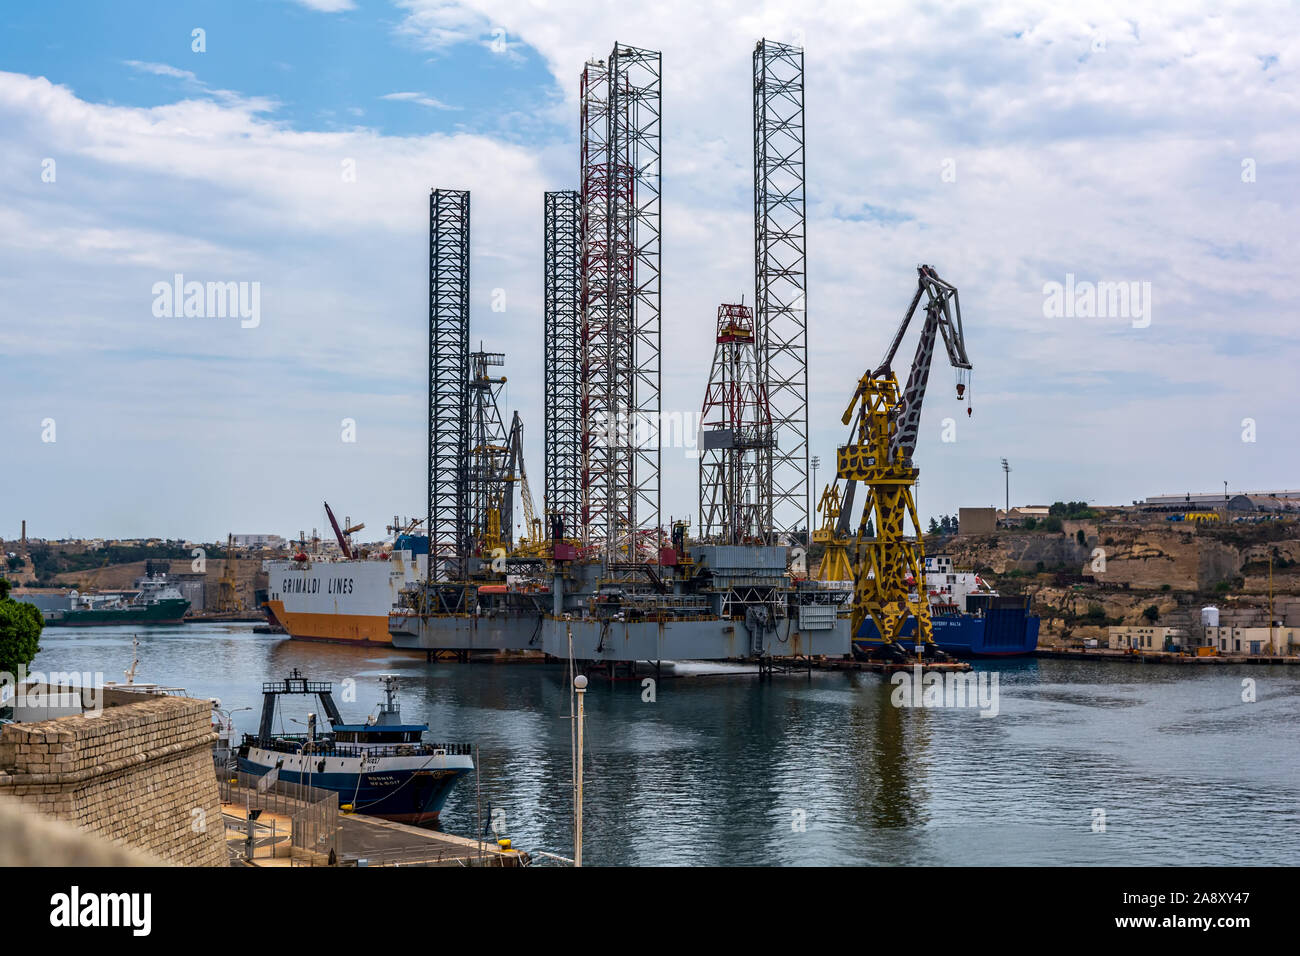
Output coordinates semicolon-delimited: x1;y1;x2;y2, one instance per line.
853;555;1039;657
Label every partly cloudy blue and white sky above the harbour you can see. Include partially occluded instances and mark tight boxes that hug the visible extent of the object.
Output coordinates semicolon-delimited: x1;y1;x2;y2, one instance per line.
0;0;1300;540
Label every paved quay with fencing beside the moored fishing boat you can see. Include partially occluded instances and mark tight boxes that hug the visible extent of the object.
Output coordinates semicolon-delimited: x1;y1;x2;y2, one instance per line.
218;773;530;868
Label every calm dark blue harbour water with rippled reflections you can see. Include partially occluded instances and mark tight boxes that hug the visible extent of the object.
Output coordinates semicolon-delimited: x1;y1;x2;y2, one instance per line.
33;624;1300;865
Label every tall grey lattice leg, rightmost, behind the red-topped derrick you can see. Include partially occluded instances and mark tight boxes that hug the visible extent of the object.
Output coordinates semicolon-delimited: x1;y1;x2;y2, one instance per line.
754;40;810;538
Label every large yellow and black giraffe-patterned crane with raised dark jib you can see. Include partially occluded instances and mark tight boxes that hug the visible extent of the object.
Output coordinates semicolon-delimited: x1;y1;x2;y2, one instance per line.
836;265;971;658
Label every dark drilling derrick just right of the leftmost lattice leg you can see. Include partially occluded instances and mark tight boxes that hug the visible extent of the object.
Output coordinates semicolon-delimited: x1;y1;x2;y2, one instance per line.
467;351;515;558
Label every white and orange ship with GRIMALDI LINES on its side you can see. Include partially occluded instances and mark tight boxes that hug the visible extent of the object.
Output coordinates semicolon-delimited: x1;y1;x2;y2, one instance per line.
261;535;429;645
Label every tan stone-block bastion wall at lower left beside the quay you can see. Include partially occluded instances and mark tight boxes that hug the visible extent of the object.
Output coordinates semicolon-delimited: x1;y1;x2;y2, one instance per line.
0;691;228;866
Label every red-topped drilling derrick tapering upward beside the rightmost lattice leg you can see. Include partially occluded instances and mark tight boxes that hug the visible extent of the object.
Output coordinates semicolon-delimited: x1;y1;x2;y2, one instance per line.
699;304;772;545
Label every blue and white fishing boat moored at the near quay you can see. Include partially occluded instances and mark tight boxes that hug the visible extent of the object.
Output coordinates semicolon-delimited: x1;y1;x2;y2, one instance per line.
238;669;475;823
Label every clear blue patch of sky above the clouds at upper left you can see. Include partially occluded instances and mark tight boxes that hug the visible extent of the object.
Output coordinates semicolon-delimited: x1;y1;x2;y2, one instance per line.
0;0;566;135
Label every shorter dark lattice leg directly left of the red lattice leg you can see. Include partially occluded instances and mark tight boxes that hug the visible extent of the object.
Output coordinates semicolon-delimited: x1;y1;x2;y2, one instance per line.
540;190;584;537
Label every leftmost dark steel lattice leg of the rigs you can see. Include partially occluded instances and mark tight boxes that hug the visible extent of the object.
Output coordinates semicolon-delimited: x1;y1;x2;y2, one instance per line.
425;189;469;581
